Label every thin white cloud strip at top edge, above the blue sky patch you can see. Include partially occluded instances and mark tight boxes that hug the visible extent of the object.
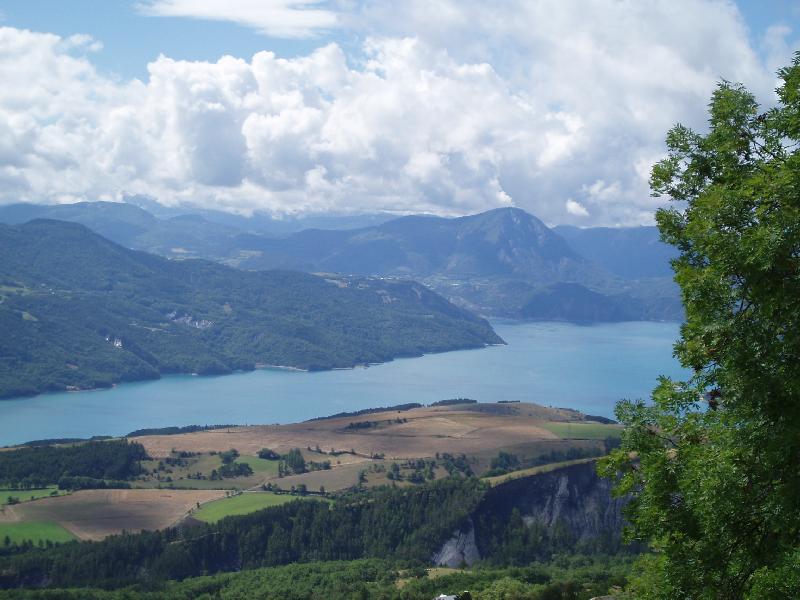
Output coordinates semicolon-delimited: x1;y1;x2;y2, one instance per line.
138;0;337;38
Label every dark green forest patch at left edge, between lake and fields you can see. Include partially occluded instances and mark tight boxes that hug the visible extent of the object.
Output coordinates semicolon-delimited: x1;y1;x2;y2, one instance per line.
0;440;147;489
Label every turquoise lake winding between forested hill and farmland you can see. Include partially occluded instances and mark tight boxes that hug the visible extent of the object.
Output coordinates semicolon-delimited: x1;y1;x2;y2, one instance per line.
0;321;686;445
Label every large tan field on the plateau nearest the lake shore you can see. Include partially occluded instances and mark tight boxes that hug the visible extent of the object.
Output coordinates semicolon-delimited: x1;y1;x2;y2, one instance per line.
136;403;584;461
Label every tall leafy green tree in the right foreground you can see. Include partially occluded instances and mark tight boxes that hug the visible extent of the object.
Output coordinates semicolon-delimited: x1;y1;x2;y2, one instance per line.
601;54;800;599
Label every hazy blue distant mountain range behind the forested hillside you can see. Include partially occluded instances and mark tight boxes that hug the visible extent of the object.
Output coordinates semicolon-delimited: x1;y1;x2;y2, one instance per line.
0;202;682;322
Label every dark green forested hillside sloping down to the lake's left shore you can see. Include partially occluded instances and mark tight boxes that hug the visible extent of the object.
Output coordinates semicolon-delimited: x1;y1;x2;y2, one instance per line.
0;220;502;397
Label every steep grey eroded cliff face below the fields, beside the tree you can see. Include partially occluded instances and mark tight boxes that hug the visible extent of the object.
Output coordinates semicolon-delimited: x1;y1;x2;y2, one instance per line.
433;462;625;567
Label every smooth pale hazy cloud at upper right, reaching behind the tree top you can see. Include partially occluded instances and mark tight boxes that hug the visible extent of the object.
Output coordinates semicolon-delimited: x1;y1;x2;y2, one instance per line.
351;0;796;224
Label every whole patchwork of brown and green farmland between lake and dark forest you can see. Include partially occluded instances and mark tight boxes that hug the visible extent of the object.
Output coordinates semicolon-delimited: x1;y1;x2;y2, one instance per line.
0;403;619;540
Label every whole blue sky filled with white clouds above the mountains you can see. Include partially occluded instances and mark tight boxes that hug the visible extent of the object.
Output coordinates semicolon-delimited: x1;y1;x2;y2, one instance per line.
0;0;800;226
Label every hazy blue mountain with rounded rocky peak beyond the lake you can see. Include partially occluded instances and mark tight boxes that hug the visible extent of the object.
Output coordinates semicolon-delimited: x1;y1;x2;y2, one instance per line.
241;208;594;281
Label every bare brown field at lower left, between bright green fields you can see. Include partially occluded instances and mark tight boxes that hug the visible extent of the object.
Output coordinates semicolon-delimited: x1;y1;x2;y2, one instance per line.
6;490;225;540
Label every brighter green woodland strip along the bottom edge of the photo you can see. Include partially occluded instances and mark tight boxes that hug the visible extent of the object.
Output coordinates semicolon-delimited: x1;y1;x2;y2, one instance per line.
0;555;630;600
